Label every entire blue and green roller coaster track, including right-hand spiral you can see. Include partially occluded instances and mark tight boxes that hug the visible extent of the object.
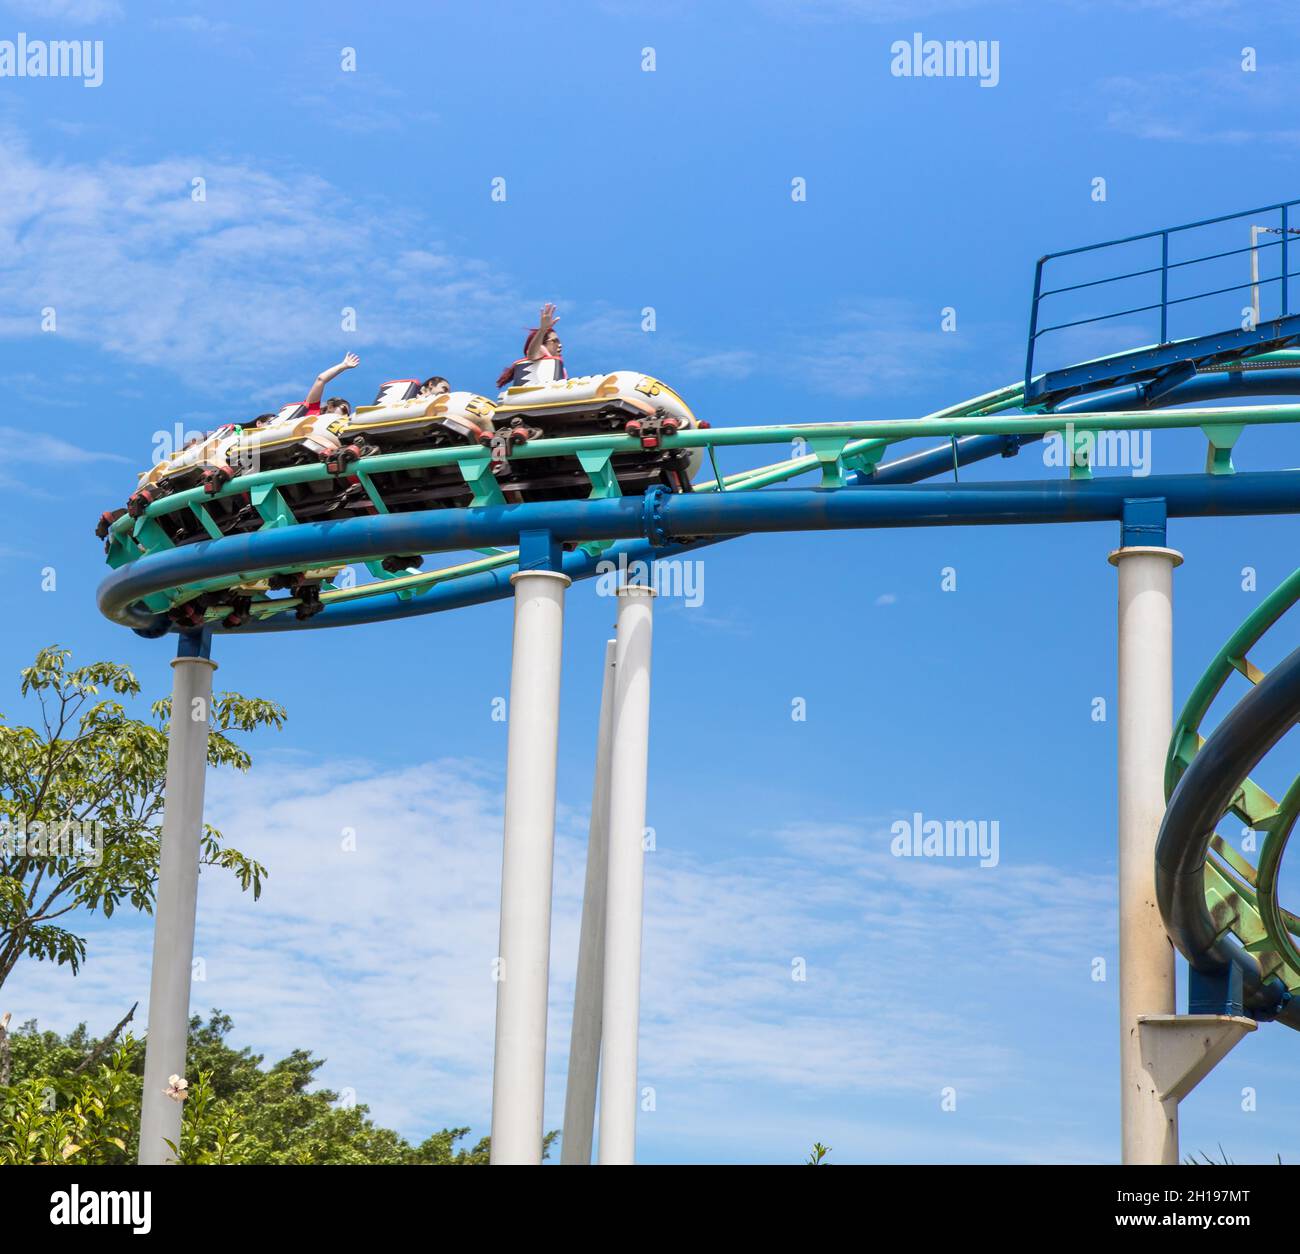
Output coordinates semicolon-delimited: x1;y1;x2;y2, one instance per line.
99;350;1300;1027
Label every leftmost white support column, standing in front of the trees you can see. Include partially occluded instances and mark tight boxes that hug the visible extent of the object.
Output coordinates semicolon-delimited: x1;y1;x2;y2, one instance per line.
139;656;217;1166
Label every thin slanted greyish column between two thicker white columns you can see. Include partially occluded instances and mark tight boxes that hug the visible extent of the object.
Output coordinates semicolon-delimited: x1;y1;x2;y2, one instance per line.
560;641;616;1166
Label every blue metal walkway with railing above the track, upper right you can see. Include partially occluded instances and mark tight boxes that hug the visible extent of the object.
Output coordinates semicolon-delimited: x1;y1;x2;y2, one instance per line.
1024;200;1300;409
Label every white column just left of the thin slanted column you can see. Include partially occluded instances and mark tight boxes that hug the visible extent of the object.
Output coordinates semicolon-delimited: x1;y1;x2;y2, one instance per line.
491;570;571;1163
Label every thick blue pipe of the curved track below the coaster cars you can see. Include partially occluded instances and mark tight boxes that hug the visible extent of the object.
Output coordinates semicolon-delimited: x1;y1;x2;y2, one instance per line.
99;470;1300;632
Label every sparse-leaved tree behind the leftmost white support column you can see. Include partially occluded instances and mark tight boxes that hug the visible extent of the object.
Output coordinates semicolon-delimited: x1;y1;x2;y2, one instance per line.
0;647;285;985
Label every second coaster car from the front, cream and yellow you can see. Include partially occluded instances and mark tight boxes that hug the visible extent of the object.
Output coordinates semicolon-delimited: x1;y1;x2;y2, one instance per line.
326;379;497;513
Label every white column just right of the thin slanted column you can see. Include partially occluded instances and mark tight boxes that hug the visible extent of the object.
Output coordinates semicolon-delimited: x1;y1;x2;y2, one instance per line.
599;583;654;1164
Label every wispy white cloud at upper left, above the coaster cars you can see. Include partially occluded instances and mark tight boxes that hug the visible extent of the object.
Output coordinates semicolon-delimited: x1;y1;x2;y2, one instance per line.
0;131;516;385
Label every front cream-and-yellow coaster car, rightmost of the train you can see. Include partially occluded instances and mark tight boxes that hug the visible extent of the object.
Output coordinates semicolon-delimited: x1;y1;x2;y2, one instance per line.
495;370;703;500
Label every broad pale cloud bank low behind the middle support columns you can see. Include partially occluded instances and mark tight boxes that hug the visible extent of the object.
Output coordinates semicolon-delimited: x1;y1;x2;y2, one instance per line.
4;759;1110;1157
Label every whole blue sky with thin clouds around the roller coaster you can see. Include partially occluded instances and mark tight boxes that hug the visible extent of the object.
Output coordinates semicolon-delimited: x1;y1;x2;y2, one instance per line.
0;0;1300;1162
